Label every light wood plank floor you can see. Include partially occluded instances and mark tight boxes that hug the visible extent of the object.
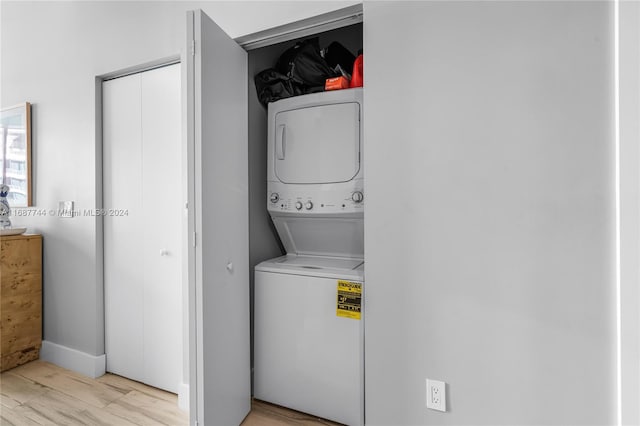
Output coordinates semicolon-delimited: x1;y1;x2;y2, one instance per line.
0;361;337;426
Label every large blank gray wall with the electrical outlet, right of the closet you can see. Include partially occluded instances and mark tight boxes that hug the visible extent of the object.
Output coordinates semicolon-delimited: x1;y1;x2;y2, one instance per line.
364;1;616;425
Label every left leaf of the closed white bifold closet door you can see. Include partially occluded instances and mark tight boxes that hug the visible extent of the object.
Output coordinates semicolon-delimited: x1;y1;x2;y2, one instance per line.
102;74;144;381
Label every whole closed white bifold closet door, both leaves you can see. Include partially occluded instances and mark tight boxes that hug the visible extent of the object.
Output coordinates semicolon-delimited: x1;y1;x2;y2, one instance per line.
103;65;182;392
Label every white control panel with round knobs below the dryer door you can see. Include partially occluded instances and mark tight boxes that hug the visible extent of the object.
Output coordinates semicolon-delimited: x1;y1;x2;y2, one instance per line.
267;181;365;214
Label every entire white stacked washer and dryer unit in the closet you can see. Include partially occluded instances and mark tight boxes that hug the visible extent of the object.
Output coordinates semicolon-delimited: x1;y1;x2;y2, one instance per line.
254;88;364;425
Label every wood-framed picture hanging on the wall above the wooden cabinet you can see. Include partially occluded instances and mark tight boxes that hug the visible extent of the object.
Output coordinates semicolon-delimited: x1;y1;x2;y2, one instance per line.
0;102;32;207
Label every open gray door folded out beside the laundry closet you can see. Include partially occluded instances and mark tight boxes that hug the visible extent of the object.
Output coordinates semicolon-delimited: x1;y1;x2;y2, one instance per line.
186;11;251;425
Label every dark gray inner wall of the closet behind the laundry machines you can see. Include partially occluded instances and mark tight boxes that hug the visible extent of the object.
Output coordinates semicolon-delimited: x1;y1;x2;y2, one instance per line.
248;23;363;380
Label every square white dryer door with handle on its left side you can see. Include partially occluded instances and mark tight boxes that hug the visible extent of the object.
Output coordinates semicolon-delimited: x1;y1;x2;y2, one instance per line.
274;102;360;184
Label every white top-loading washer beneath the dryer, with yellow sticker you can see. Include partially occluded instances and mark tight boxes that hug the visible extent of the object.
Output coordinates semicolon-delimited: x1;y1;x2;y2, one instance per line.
254;255;364;425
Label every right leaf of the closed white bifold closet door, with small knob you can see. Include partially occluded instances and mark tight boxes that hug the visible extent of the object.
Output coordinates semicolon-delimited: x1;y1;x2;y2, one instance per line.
140;65;182;393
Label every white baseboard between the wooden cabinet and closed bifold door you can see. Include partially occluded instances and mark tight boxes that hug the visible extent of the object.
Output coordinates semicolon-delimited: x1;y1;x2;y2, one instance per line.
40;340;107;378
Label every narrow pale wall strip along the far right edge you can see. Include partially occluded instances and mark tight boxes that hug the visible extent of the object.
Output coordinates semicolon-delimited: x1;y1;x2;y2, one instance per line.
615;1;640;425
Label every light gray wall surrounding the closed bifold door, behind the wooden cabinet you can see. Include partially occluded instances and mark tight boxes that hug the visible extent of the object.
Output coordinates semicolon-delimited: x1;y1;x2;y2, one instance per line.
0;1;356;355
